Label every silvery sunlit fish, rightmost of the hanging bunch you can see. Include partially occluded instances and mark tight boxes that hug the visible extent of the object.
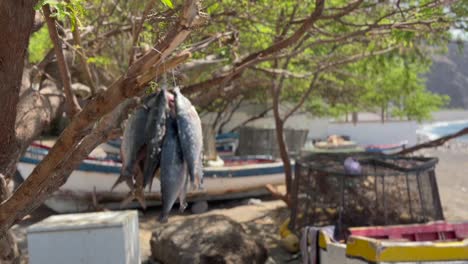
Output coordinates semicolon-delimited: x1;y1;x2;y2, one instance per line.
174;87;203;189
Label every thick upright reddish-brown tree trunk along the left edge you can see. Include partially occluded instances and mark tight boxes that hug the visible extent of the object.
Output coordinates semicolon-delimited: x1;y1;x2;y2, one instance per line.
0;0;36;263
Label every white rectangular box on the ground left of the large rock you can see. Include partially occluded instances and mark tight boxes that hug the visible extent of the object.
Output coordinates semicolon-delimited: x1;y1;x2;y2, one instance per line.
27;211;141;264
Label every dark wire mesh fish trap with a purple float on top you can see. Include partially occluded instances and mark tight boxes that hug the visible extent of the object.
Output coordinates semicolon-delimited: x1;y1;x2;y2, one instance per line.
290;153;444;238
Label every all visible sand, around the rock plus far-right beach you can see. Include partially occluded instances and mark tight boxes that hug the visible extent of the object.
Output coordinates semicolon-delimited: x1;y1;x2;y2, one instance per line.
13;145;468;263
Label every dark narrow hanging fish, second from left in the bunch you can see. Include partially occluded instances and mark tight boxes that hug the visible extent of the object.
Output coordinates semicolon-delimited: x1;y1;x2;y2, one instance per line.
143;88;168;190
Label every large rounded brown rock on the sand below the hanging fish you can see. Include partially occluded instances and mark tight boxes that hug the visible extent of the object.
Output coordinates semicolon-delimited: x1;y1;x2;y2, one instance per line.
150;215;267;264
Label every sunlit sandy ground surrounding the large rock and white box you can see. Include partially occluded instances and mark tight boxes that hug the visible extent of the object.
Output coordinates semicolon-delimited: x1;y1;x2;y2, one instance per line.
13;197;299;264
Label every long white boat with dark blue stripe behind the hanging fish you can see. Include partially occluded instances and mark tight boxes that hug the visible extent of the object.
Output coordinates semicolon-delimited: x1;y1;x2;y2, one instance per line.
18;144;284;213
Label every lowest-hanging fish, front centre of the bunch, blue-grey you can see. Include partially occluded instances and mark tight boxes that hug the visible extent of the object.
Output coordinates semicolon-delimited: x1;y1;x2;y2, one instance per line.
159;116;187;223
